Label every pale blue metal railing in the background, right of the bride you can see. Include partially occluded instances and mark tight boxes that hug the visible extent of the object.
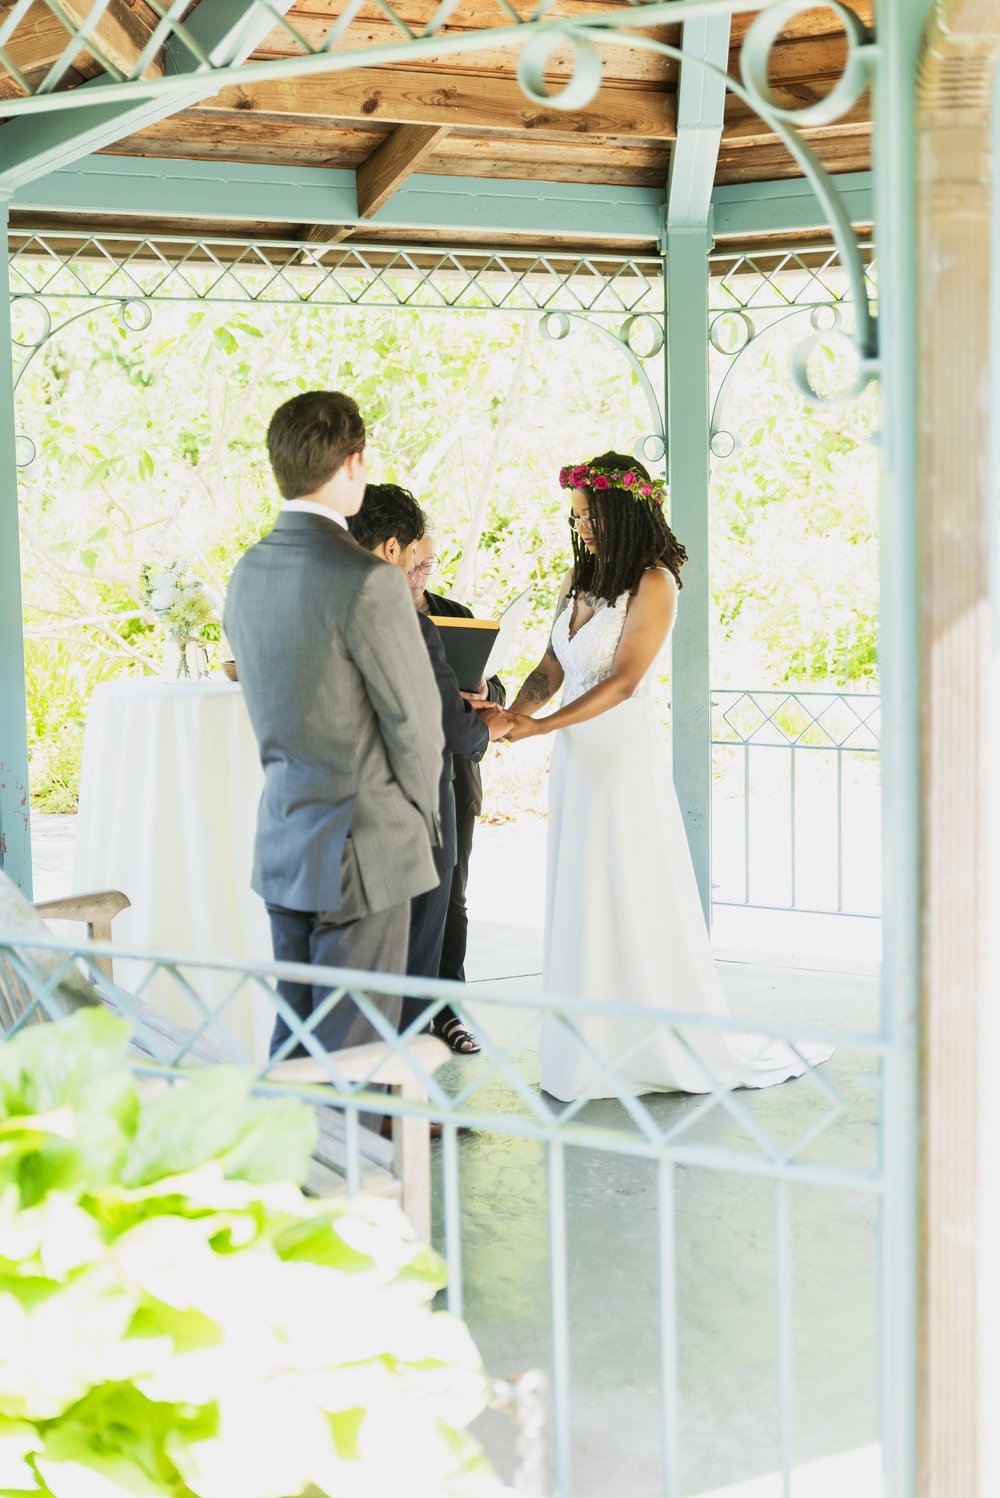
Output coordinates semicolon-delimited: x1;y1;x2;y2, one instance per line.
713;688;882;917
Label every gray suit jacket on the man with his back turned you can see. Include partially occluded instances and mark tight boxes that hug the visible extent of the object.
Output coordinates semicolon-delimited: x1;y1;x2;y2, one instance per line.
225;512;443;915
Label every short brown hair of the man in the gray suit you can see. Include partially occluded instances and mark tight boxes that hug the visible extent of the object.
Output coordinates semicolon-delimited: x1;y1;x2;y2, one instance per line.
268;389;365;499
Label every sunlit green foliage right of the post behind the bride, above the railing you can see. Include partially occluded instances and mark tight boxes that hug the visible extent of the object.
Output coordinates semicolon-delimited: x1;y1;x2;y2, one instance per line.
710;321;879;689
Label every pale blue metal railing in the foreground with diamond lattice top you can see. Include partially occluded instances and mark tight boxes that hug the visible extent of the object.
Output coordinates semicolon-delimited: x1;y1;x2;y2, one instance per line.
0;935;895;1498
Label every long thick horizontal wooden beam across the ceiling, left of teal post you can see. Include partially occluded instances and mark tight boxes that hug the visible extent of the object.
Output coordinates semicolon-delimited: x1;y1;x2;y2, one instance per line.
198;67;675;141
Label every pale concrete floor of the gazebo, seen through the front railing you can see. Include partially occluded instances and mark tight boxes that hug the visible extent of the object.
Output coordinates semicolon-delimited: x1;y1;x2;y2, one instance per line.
33;818;882;1498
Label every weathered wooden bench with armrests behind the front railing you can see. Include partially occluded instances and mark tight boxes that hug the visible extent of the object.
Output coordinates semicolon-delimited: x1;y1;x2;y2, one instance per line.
0;873;451;1242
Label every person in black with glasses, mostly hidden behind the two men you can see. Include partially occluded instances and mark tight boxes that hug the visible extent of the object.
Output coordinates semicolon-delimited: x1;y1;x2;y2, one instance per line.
407;532;507;1055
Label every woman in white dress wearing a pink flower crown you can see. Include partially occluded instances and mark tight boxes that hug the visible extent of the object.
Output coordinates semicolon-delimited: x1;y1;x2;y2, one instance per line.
488;452;829;1101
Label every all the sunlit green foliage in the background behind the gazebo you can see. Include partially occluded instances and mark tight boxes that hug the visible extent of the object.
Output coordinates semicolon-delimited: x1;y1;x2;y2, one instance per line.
19;283;877;812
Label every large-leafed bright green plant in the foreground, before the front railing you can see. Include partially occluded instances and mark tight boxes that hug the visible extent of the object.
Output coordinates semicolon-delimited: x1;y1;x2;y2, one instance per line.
0;1010;496;1498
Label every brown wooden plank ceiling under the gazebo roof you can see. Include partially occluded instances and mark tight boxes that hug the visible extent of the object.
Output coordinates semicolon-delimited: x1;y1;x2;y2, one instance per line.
0;0;873;249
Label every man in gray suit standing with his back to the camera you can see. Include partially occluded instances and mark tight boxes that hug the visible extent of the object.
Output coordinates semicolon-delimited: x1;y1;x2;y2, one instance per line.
225;391;443;1053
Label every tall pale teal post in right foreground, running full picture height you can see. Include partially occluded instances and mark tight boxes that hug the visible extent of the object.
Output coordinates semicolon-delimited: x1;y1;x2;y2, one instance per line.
873;0;931;1498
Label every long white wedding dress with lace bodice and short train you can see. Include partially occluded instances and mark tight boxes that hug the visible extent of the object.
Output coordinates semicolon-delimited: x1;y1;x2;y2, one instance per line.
539;581;831;1103
